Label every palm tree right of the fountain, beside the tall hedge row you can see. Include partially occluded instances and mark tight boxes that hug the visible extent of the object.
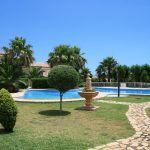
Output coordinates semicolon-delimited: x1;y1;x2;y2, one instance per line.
96;57;117;82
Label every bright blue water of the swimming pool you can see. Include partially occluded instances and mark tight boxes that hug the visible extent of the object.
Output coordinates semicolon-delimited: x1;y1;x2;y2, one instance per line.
21;87;150;99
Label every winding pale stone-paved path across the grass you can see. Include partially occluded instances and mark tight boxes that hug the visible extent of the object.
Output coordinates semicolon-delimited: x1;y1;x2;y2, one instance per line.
89;100;150;150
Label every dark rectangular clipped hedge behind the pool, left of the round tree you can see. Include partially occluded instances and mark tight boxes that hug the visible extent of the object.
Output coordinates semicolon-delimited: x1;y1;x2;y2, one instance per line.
31;78;51;89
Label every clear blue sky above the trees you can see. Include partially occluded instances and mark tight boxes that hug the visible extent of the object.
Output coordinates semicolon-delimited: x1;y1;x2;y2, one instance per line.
0;0;150;74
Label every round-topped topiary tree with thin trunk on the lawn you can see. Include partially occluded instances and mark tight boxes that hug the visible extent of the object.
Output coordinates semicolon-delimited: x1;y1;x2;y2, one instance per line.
48;65;79;110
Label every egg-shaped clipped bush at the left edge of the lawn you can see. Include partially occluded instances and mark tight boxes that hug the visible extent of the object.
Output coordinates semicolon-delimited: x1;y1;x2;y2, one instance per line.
0;89;17;132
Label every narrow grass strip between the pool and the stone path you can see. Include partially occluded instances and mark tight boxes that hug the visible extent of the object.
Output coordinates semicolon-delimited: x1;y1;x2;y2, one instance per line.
102;96;150;103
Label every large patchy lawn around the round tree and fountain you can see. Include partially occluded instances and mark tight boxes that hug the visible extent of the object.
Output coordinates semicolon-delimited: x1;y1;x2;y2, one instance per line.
0;102;134;150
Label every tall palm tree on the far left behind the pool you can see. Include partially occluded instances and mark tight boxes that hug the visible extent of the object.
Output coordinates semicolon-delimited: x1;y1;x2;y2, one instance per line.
0;37;34;92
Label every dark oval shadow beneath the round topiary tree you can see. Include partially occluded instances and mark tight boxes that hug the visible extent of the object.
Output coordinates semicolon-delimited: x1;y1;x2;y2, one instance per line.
39;110;71;116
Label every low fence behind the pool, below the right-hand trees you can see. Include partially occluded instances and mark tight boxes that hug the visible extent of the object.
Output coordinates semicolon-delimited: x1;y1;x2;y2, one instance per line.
92;82;150;88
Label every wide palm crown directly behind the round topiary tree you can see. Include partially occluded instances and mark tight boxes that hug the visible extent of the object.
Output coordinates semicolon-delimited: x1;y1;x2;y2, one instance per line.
48;45;87;72
